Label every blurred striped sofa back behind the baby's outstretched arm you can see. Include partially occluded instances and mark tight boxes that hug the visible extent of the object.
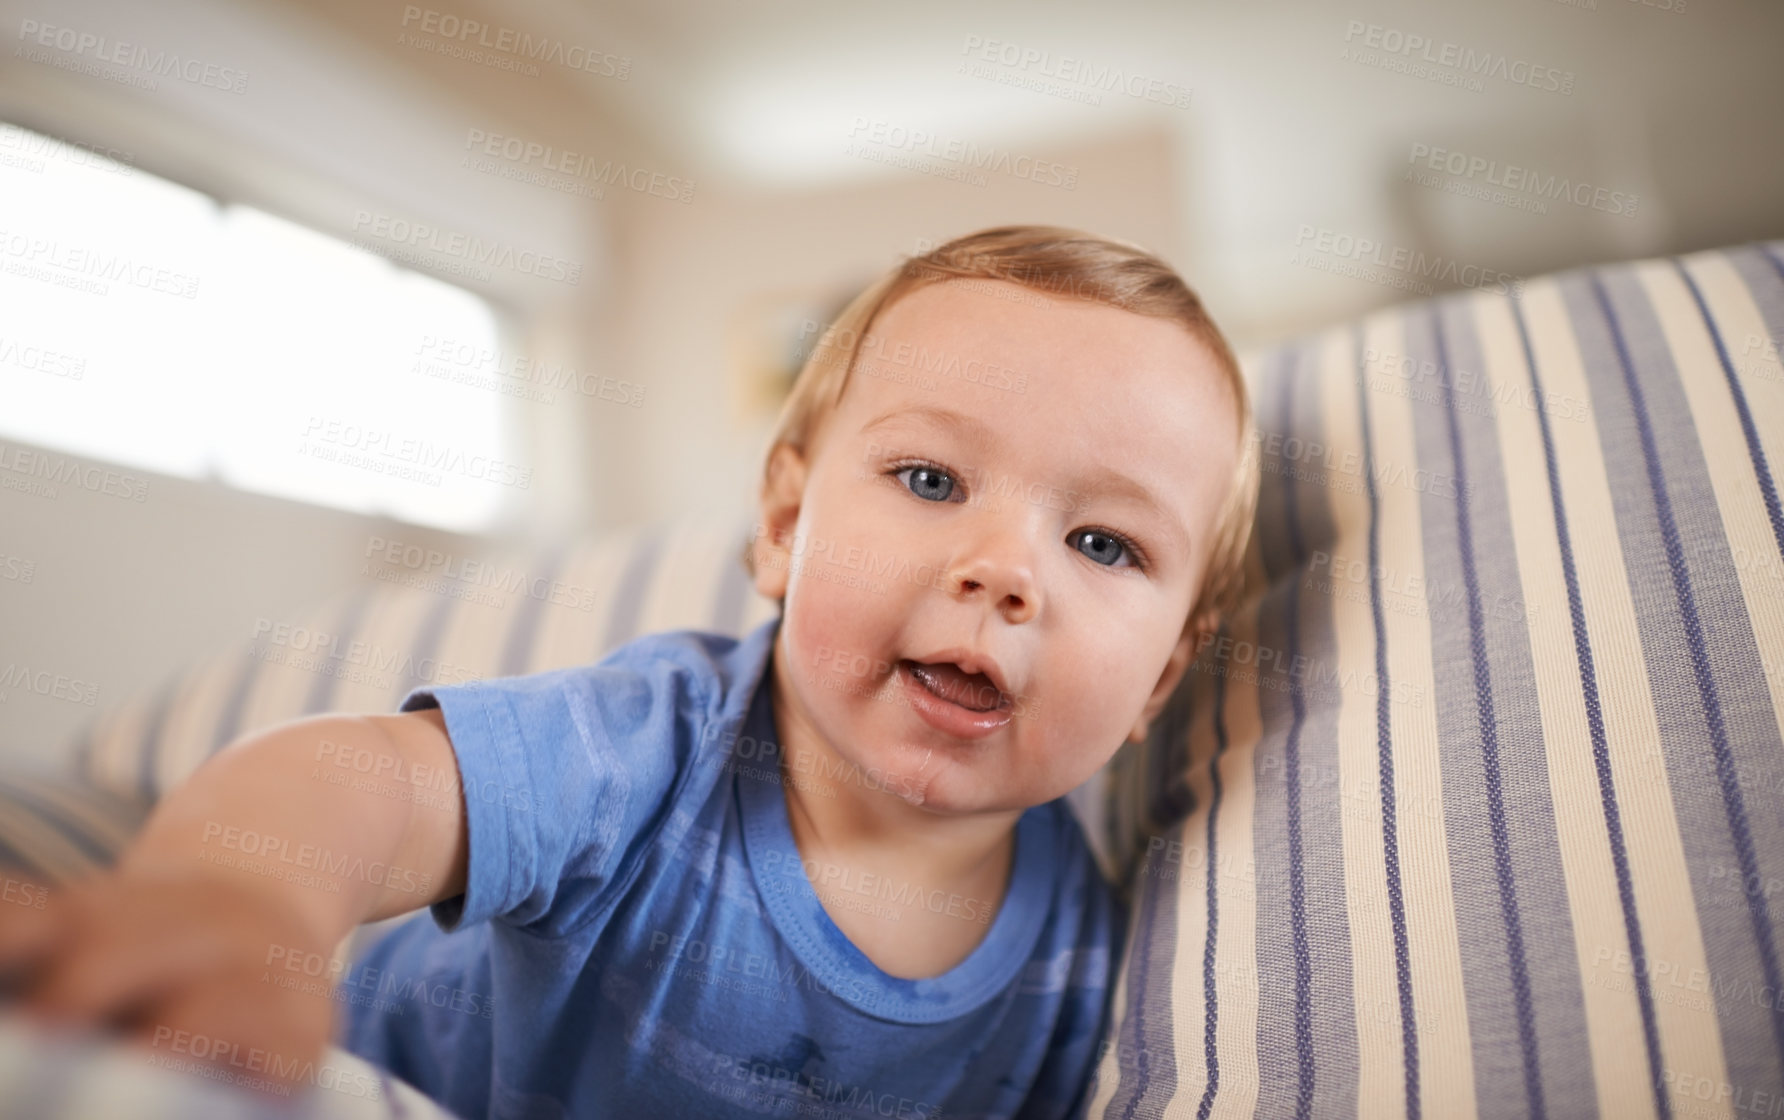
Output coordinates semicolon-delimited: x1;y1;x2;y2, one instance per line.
77;515;776;803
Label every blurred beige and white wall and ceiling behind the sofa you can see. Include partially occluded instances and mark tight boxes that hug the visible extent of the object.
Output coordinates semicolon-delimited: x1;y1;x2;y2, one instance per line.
0;0;1784;762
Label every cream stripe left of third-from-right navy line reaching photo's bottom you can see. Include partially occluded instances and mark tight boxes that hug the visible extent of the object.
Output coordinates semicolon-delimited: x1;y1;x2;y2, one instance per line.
1334;316;1416;1120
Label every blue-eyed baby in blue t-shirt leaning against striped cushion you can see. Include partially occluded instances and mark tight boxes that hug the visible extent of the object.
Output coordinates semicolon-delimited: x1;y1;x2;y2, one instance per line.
0;226;1256;1120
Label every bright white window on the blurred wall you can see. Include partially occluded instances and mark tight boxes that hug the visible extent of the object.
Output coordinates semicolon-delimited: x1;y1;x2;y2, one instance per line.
0;125;517;531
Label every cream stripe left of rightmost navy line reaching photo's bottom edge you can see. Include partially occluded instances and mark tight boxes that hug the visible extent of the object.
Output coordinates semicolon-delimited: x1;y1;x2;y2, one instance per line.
1475;284;1654;1120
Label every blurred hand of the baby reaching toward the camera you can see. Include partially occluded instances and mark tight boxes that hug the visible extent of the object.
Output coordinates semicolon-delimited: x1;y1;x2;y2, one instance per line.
0;869;334;1090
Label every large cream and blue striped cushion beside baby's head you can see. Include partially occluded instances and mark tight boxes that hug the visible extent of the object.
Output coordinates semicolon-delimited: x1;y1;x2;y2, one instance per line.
1090;243;1784;1120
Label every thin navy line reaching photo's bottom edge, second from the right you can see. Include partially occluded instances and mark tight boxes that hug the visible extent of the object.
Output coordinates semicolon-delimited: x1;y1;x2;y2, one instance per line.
1408;305;1549;1116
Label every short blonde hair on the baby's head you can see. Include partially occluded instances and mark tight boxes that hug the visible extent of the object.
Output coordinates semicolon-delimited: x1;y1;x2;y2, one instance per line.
742;225;1258;628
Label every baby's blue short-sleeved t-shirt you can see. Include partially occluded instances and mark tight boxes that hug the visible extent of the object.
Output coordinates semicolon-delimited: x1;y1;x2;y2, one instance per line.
341;619;1126;1120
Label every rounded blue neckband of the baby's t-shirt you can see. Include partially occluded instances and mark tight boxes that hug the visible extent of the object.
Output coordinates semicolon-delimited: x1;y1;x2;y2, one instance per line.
733;631;1056;1024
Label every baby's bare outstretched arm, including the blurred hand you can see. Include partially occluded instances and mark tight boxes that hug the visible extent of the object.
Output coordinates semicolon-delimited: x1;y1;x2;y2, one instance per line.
0;710;467;1081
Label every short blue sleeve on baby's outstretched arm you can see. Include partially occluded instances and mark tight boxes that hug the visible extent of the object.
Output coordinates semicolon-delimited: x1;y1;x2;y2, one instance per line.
401;647;715;936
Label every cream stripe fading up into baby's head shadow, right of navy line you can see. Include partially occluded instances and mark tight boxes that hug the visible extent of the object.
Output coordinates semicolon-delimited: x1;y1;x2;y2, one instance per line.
1205;601;1263;1120
